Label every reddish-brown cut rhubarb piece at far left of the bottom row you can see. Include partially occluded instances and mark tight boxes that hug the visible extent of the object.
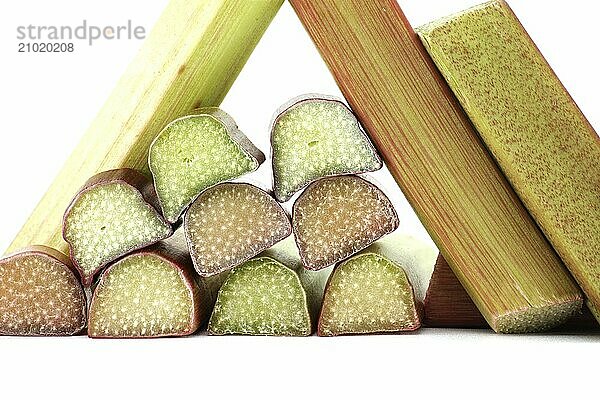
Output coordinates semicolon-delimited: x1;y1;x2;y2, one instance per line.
0;246;86;336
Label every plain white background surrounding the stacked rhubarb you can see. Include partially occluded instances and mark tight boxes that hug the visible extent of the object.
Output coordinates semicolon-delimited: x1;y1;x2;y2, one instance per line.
0;0;600;399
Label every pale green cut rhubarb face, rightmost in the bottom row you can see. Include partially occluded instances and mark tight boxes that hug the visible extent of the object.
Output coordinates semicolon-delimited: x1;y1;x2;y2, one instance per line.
318;253;421;336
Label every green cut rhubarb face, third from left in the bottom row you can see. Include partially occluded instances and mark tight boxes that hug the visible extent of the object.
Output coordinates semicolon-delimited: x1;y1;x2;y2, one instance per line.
208;257;311;336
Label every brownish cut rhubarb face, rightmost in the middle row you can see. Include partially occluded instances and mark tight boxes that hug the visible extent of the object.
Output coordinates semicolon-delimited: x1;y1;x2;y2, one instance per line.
292;175;398;270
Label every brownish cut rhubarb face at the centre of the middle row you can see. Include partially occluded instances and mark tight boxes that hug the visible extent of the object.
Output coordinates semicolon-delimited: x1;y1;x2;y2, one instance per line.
184;183;292;276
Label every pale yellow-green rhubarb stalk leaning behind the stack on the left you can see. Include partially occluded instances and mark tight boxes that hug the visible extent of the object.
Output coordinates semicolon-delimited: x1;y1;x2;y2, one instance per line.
8;0;283;254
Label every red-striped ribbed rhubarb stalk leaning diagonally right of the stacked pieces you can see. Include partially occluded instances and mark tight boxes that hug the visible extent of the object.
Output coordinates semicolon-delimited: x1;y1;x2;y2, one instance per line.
290;0;580;331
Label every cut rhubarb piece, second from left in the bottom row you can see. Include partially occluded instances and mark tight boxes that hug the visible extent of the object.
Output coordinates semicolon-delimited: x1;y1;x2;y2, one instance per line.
88;243;204;338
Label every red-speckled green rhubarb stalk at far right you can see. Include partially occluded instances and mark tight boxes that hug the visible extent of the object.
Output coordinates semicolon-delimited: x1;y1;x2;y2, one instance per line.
419;0;600;322
